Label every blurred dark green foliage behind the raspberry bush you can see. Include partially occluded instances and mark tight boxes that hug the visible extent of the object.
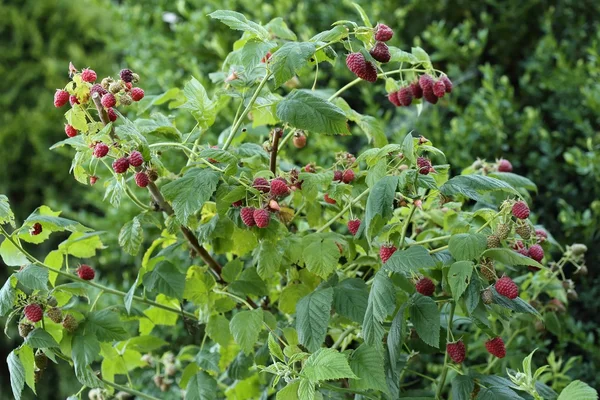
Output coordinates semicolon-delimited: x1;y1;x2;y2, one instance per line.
0;0;600;398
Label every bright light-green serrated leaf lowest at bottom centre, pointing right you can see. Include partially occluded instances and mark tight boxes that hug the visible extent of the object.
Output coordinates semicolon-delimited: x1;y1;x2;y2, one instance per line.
301;349;357;383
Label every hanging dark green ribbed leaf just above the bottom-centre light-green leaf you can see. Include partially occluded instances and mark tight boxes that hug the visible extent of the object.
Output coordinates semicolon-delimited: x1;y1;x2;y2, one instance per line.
296;288;333;351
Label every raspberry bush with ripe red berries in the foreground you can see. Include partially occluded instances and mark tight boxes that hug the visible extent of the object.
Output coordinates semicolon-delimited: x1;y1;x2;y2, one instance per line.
0;6;597;400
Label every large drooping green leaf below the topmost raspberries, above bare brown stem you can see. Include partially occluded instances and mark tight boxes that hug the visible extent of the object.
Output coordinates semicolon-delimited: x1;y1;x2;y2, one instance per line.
276;89;349;135
